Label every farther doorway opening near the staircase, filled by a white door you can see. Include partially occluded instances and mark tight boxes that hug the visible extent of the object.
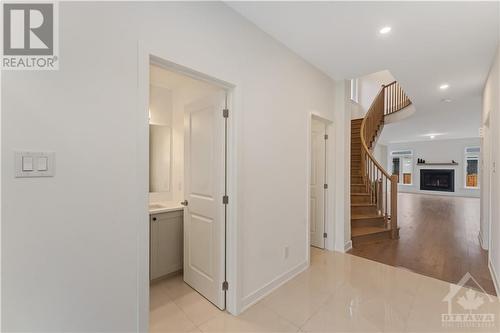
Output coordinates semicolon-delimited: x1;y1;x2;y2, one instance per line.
308;115;331;249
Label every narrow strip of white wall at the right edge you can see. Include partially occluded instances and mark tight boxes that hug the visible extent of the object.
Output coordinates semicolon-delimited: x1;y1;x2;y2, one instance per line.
480;44;500;293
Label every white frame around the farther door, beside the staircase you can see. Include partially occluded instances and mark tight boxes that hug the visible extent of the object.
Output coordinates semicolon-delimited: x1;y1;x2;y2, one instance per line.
306;111;335;264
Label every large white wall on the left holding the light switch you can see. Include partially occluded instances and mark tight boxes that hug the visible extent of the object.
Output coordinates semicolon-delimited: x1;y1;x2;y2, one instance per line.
2;2;349;332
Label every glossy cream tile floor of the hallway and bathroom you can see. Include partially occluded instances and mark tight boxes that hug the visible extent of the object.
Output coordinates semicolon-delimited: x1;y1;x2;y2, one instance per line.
150;249;500;333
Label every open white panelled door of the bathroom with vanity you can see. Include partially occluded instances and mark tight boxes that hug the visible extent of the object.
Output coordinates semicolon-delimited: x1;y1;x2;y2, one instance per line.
184;91;226;309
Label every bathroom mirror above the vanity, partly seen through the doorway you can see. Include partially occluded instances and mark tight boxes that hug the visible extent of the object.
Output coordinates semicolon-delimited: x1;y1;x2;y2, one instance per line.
149;124;172;192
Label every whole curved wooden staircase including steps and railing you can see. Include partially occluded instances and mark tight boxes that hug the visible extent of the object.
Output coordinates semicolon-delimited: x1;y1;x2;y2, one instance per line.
351;82;411;246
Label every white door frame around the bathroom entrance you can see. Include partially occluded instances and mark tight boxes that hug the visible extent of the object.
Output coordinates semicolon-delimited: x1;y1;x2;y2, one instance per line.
135;41;241;332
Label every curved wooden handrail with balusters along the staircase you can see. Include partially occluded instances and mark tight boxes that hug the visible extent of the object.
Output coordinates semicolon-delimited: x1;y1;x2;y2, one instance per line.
360;81;411;238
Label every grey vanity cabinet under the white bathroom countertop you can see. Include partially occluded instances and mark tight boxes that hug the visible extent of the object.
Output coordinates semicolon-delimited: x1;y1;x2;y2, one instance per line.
149;210;183;280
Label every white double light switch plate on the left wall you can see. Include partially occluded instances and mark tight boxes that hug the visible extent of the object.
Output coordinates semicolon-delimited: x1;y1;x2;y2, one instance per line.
14;151;56;178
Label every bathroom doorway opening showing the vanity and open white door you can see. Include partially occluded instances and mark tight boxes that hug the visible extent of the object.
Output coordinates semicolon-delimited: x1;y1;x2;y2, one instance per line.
148;59;229;331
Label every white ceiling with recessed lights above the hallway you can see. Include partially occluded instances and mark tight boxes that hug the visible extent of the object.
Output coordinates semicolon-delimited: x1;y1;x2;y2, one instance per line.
228;2;500;143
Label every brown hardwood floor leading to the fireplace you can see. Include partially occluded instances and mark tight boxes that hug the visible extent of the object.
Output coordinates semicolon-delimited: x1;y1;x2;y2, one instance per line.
350;193;496;295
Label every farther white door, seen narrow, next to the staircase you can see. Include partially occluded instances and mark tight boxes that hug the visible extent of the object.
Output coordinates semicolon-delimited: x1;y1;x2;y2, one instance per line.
309;118;326;248
